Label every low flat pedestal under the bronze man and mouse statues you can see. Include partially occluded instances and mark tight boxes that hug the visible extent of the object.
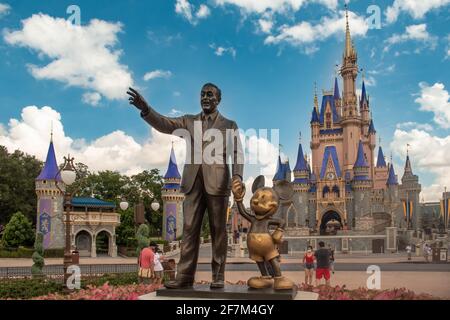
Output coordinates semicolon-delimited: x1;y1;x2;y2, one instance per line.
139;284;318;300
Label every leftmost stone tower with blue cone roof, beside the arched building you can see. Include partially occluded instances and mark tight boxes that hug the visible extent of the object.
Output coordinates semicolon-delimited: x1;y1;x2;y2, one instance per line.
36;138;65;249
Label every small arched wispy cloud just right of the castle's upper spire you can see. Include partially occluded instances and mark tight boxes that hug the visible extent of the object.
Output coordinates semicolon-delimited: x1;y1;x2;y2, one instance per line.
383;23;437;52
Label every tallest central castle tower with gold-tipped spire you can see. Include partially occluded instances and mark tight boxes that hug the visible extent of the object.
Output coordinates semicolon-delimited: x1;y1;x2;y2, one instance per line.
341;6;361;175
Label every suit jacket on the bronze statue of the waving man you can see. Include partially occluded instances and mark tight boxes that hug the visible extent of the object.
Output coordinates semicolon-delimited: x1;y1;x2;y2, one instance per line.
141;108;244;196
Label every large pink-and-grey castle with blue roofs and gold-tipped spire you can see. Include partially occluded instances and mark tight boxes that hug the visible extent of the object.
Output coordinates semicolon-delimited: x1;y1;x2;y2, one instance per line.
273;8;421;235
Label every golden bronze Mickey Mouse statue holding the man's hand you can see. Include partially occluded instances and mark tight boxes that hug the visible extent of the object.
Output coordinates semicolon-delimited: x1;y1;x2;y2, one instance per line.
232;176;294;290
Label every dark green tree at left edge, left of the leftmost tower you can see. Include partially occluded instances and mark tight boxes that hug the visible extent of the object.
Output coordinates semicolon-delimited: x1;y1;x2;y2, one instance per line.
0;146;43;224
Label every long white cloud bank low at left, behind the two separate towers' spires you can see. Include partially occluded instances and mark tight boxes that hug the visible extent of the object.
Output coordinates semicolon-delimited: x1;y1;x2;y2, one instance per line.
0;106;186;174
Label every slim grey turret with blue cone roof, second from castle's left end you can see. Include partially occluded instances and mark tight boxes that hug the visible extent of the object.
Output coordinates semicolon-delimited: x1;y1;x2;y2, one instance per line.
293;137;310;226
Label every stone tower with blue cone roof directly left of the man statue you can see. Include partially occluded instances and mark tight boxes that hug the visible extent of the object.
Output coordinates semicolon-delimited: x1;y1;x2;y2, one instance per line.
161;144;184;241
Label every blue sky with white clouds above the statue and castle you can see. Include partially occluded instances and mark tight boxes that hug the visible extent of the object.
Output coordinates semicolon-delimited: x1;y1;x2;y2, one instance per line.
0;0;450;199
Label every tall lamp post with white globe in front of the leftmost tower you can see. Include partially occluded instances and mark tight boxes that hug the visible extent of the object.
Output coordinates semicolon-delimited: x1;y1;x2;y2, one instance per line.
55;154;77;291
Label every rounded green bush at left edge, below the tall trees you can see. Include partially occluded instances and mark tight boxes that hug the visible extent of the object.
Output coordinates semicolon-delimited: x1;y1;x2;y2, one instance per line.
2;212;34;248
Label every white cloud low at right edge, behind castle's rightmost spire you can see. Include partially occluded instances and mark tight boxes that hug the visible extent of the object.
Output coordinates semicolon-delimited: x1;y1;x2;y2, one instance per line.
390;129;450;201
